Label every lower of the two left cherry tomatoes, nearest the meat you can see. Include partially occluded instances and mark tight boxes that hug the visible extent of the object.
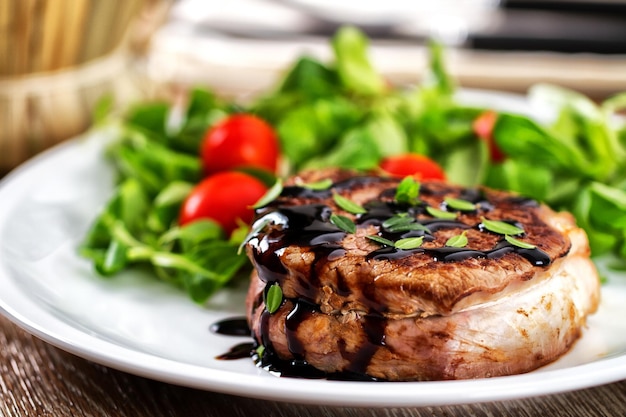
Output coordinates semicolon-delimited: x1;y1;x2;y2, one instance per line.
179;171;267;235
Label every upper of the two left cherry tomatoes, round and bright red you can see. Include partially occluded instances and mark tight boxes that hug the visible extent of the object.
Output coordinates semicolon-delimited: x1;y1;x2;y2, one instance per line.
200;113;279;175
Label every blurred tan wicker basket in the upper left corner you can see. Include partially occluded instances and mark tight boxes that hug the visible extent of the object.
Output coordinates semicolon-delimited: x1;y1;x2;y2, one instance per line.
0;0;169;174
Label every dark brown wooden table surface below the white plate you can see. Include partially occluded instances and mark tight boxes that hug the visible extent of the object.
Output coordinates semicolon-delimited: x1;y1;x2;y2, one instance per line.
0;317;626;417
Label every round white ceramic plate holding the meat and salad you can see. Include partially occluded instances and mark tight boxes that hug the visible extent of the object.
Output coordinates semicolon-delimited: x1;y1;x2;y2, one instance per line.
0;92;626;407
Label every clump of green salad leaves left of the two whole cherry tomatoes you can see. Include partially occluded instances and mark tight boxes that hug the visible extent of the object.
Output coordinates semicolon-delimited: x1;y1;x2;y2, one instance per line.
80;90;248;303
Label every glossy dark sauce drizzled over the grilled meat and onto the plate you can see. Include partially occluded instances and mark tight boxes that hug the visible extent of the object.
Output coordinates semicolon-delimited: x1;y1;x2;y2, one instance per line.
217;177;551;381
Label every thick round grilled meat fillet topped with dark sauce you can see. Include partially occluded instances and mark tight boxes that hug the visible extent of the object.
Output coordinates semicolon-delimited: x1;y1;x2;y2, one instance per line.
241;170;599;381
